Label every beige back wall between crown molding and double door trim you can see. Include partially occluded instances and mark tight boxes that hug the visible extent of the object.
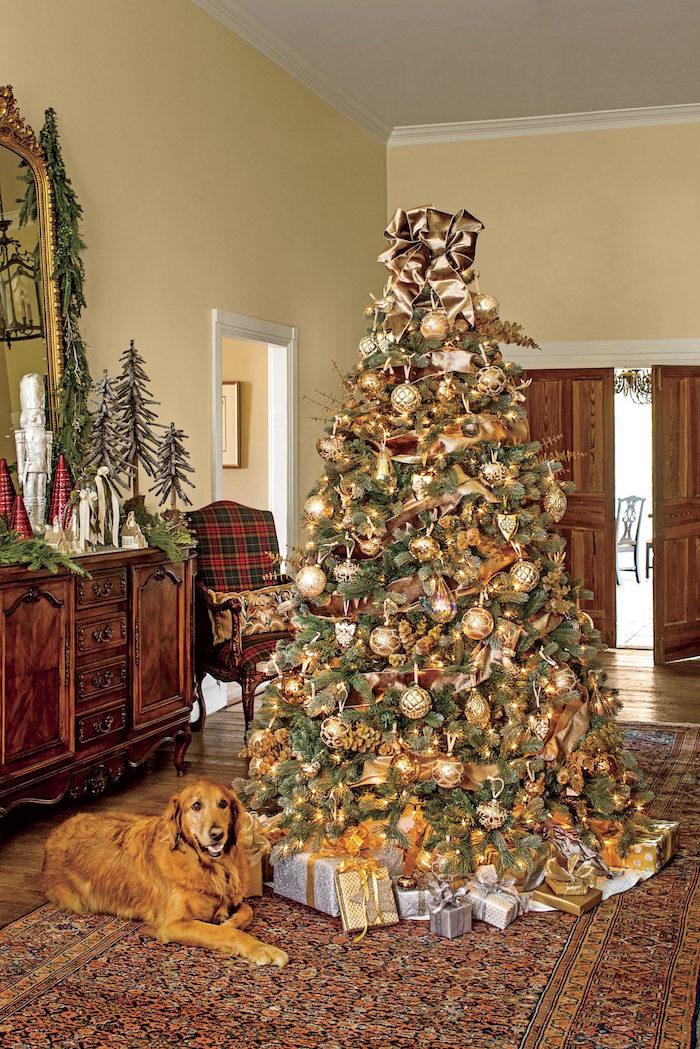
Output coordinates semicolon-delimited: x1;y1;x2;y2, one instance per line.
387;124;700;342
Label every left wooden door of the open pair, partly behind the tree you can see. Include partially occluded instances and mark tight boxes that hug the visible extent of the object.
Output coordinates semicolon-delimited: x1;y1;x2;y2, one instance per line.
527;368;615;646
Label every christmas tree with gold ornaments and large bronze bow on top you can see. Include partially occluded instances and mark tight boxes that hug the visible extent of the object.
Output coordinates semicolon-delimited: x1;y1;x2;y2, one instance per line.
237;208;648;875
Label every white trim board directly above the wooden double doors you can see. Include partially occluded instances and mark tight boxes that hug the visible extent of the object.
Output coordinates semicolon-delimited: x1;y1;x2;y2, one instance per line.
503;339;700;371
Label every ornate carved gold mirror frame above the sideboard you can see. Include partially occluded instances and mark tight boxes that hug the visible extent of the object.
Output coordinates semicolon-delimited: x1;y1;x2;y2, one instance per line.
0;86;63;433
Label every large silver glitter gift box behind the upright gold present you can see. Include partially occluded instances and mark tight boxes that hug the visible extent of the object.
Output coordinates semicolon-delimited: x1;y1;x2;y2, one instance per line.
273;848;403;918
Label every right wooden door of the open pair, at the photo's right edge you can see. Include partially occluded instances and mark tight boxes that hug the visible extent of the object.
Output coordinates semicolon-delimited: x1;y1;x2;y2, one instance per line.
652;366;700;663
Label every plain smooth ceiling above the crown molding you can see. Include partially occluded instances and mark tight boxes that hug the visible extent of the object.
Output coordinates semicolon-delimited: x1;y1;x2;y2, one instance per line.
195;0;700;136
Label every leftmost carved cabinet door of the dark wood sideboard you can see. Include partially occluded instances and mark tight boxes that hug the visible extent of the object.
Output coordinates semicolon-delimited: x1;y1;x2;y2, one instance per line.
0;579;73;774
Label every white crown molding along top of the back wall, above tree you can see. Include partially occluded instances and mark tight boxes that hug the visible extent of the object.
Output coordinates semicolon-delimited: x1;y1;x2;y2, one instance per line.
392;103;700;147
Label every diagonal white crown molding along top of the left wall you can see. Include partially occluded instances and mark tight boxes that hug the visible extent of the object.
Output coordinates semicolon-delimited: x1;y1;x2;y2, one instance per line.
188;0;391;143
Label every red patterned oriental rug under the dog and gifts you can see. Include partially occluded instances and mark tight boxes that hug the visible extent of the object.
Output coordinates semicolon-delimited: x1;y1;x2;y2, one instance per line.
0;725;700;1049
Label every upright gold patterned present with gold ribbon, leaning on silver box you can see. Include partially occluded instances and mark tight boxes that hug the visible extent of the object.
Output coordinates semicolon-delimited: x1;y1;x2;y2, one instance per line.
334;857;399;943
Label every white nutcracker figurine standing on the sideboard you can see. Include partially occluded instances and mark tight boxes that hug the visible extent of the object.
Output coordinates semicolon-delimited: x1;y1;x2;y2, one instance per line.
15;371;54;536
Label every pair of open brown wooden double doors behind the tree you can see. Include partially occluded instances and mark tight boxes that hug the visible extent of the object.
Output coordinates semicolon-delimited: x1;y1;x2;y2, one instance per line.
528;365;700;663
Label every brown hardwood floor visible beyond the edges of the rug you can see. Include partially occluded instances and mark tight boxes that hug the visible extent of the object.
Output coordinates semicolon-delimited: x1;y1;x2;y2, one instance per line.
0;648;700;925
